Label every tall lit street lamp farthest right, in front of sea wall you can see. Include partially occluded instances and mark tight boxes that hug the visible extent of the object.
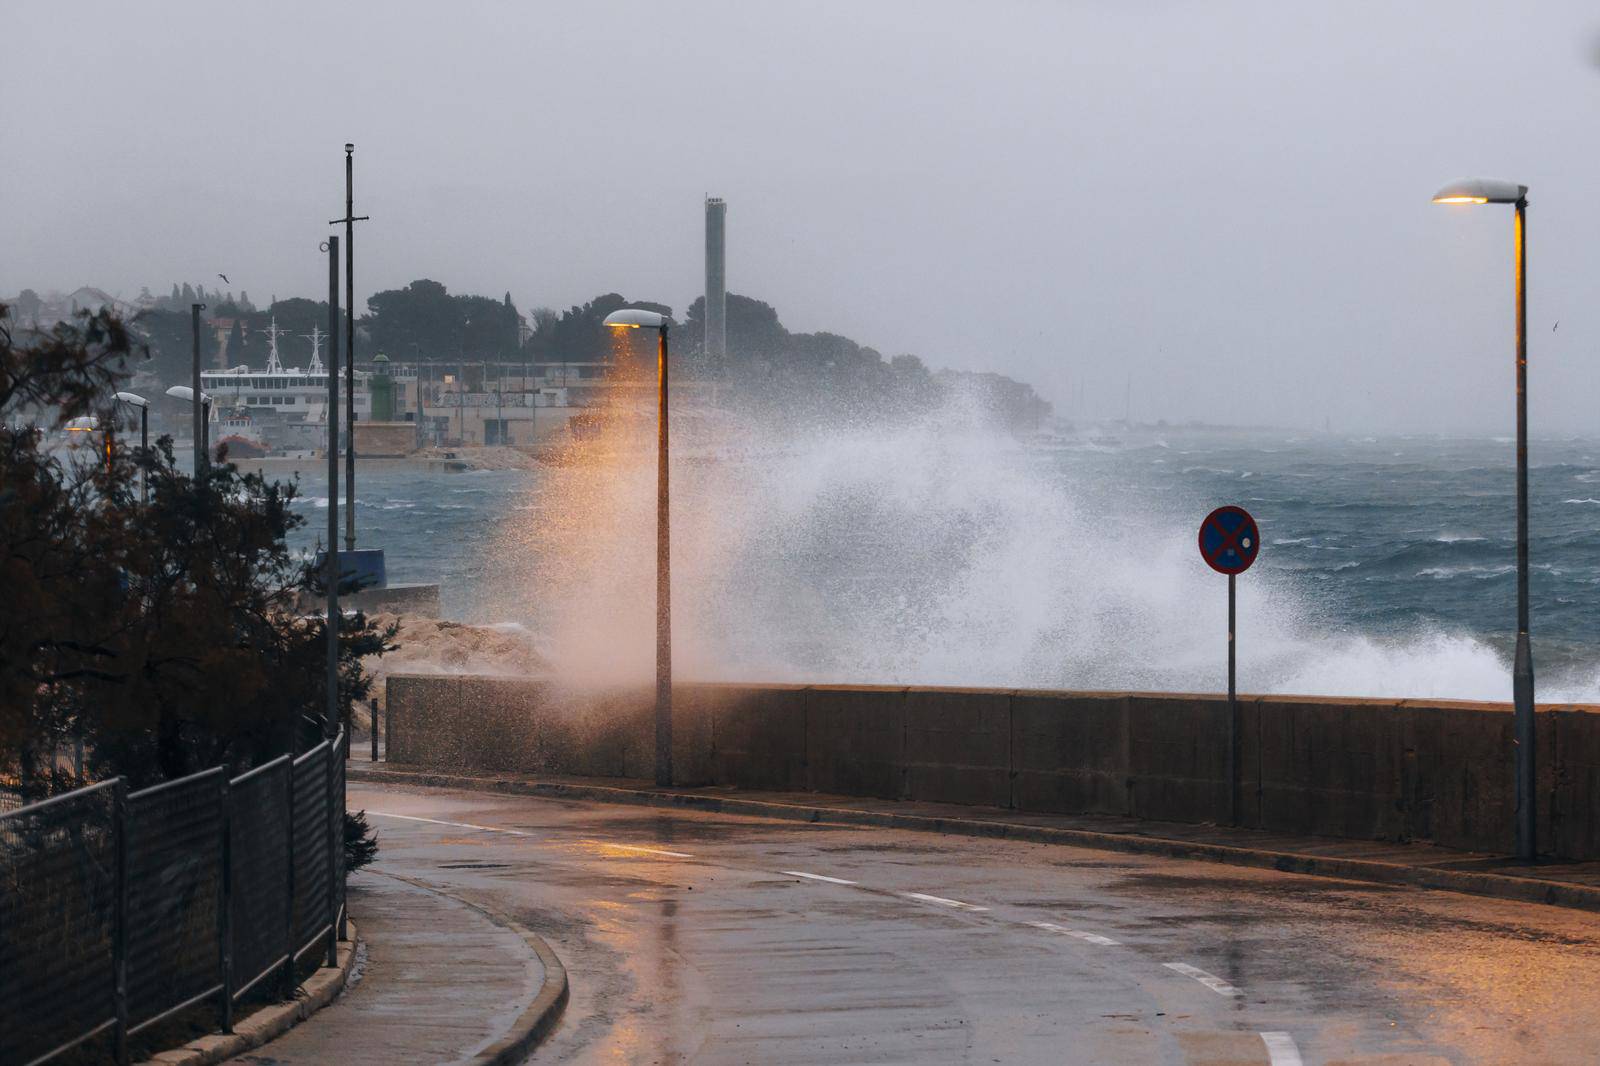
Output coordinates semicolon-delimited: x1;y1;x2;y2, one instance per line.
1434;178;1539;863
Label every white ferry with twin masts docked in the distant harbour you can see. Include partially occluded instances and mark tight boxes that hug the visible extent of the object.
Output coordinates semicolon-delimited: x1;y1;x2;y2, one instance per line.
200;319;373;447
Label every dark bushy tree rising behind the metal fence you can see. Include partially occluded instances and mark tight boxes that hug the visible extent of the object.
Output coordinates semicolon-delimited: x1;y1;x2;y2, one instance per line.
0;307;392;792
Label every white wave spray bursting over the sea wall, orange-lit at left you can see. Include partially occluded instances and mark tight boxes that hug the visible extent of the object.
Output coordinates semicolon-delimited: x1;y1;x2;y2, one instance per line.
493;393;1600;701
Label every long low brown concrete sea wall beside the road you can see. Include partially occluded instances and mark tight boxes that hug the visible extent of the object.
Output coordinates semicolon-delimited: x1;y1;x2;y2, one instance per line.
387;674;1600;860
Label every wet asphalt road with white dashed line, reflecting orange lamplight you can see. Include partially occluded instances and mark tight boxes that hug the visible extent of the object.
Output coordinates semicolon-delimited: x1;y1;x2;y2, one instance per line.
350;784;1600;1066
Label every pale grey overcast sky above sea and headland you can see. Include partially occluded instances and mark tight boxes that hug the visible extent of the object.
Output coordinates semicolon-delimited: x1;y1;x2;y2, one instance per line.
0;0;1600;434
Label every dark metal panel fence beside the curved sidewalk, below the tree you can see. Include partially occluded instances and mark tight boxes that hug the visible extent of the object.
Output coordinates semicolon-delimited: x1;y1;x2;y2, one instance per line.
0;733;344;1066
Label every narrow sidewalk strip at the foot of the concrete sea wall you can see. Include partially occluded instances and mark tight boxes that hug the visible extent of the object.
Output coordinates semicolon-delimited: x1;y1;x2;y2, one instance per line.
349;751;1600;911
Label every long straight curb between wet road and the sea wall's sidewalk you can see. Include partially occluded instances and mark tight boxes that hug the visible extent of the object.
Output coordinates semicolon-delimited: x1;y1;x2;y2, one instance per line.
347;767;1600;911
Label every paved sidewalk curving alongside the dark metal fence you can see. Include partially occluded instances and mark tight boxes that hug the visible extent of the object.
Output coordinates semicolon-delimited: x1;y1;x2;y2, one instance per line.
232;871;565;1066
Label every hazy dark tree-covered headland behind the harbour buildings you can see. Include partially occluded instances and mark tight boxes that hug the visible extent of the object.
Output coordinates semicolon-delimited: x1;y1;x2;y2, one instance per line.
25;279;1050;432
